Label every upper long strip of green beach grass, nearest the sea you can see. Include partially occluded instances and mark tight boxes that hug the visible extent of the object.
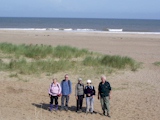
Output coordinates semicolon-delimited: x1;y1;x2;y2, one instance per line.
0;43;92;59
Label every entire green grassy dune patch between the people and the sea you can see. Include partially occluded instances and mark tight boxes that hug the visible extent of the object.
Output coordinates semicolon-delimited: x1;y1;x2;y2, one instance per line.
0;43;140;77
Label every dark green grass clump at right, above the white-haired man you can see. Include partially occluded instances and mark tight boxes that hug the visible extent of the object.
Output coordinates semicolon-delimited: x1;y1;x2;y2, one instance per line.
83;55;139;71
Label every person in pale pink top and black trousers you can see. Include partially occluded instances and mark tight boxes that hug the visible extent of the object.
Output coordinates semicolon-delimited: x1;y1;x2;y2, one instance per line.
48;78;61;111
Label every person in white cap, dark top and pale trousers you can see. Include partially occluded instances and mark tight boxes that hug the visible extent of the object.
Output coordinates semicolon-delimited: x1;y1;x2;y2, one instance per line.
84;80;95;114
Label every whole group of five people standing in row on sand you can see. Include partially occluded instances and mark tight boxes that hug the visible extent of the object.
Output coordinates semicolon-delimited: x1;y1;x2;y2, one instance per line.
48;74;111;117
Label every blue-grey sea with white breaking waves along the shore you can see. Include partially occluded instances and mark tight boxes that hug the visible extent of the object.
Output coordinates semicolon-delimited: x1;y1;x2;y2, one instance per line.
0;17;160;34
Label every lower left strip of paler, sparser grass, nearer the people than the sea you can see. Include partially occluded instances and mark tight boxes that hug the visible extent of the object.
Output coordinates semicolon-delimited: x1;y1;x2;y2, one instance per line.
5;59;74;74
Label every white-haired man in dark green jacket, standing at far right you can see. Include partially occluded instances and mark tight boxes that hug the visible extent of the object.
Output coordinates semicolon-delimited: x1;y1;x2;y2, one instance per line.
98;75;111;117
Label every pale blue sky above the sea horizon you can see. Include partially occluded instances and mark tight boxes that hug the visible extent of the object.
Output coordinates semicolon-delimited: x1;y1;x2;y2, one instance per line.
0;0;160;19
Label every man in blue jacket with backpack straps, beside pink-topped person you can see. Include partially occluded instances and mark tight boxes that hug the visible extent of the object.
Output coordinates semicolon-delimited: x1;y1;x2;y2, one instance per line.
60;74;72;111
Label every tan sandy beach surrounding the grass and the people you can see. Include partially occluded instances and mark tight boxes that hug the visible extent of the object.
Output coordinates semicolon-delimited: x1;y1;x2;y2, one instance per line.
0;30;160;120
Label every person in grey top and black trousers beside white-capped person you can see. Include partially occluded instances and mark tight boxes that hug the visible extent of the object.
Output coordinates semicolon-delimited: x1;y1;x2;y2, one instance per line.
75;78;84;112
